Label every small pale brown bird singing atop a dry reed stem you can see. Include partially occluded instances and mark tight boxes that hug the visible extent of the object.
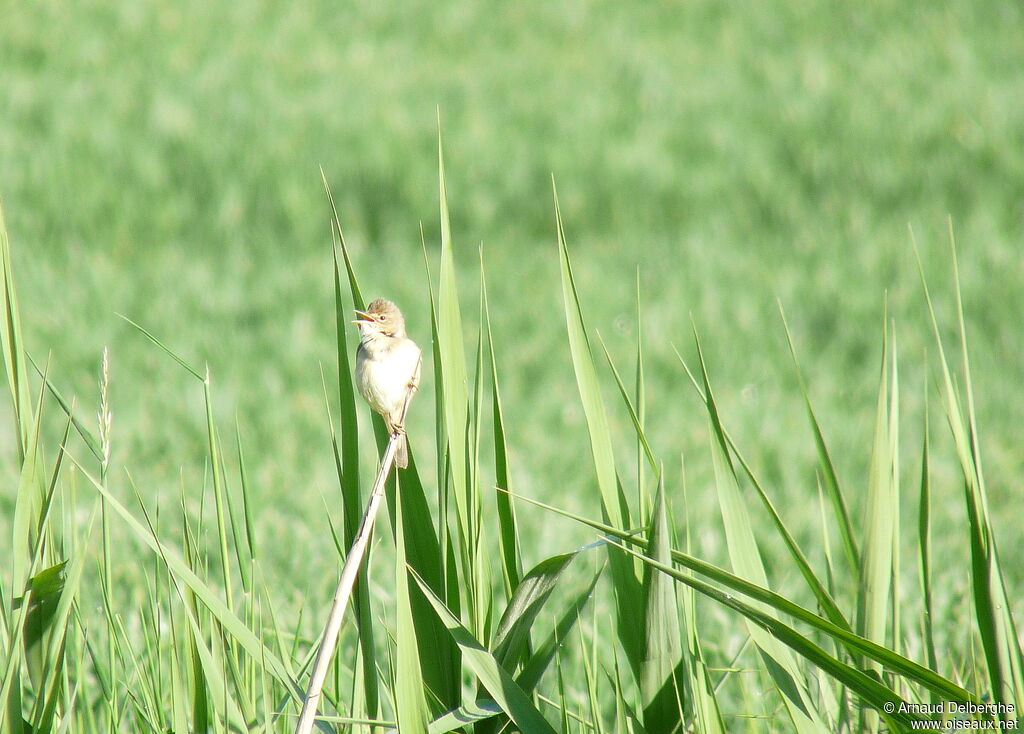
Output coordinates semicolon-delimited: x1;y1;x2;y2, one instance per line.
352;298;422;469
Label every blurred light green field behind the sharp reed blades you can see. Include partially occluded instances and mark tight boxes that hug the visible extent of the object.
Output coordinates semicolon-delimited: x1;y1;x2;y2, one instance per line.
0;0;1024;577
